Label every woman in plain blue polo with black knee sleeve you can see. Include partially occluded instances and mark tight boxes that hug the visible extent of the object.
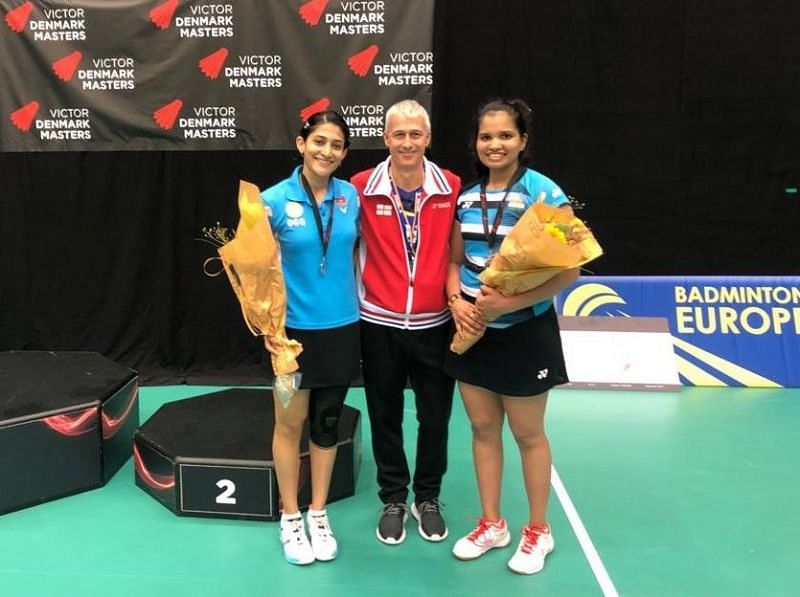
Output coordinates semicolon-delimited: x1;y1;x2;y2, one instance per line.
261;111;360;564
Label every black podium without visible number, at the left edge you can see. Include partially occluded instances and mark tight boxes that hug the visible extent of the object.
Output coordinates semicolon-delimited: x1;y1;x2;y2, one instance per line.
0;351;139;514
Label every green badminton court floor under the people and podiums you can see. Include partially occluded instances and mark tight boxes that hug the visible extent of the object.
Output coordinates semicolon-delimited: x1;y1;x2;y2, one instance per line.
0;386;800;597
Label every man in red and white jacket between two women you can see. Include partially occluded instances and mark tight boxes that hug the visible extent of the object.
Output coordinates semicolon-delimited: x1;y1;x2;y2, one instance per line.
351;100;461;545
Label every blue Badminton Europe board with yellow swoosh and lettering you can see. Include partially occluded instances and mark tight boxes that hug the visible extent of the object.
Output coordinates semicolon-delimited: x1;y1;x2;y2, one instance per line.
557;276;800;388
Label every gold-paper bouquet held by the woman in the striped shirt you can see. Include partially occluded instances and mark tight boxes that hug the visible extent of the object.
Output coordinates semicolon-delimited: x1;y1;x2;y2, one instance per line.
450;194;603;354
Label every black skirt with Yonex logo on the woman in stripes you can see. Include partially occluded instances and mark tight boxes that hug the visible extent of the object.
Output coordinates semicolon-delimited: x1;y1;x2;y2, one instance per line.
444;307;569;396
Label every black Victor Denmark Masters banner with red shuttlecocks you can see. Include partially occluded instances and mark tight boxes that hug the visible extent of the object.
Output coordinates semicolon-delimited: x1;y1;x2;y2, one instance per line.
0;0;434;151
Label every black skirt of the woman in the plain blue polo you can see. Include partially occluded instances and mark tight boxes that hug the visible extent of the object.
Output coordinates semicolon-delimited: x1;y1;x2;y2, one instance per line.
268;322;361;390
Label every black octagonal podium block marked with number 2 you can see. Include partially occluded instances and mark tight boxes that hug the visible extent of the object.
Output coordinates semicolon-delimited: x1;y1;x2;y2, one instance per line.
133;389;361;520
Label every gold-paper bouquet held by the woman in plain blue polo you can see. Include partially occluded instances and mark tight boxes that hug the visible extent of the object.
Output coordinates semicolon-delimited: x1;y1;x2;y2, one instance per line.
205;180;303;404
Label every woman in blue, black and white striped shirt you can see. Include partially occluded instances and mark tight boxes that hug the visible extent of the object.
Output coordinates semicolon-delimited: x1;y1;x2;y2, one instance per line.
445;100;578;574
